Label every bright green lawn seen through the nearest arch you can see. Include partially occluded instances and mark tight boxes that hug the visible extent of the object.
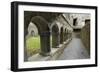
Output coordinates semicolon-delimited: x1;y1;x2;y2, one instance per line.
26;36;40;56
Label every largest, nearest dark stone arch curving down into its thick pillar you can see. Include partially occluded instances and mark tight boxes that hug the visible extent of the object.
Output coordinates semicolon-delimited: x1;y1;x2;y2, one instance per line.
30;16;51;56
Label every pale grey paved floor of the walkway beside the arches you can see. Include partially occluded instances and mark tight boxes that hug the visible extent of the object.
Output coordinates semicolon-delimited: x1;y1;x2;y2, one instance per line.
58;37;89;60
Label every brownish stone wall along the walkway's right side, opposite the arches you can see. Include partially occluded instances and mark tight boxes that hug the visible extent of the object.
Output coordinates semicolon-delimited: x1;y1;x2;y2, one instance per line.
80;20;90;54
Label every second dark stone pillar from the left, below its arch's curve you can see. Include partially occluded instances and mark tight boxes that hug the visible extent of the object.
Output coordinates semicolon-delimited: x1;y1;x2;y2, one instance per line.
52;32;60;48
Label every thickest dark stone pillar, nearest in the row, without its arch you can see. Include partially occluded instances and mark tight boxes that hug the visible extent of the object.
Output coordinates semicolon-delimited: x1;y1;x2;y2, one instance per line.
40;31;51;56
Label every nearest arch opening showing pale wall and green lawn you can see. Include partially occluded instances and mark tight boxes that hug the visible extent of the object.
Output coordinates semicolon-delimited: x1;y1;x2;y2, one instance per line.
26;22;41;57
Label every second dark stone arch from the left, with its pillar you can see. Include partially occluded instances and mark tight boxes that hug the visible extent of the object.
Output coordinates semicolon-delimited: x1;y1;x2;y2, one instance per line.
52;24;60;48
